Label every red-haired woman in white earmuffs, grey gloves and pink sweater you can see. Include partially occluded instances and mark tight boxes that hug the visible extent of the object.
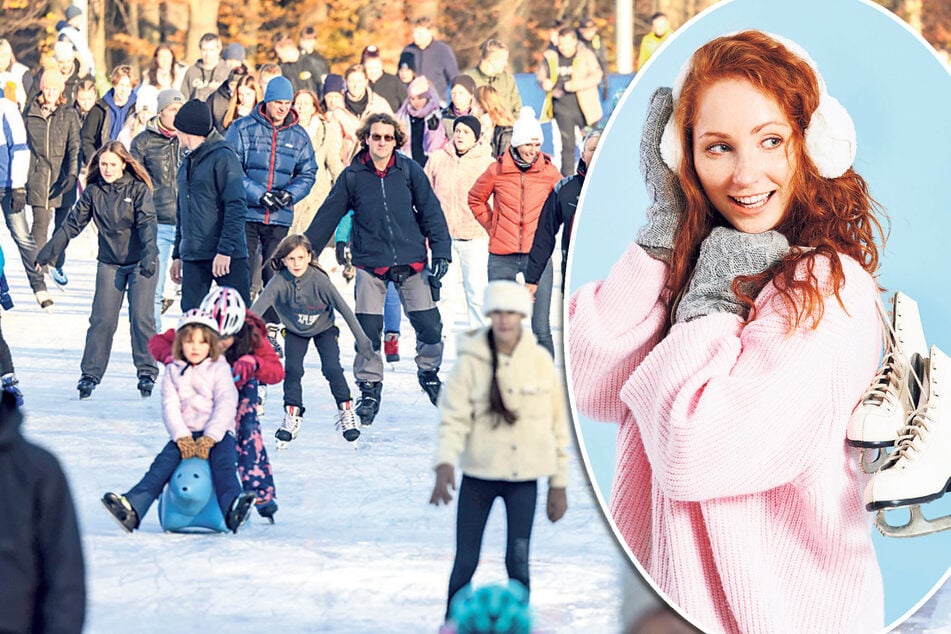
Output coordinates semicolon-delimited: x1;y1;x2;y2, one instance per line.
569;31;884;632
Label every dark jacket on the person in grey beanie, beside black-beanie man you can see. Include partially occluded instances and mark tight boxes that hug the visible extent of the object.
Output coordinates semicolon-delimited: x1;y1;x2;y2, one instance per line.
129;117;182;225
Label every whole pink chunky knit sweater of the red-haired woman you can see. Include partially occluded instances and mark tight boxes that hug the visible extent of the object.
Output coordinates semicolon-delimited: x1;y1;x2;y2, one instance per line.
568;245;884;633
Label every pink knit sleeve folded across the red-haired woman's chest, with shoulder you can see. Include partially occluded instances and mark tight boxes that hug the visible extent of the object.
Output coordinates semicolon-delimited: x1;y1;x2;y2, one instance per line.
621;256;882;501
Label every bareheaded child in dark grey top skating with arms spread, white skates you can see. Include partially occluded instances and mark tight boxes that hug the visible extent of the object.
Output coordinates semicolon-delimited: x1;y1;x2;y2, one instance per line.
251;234;373;449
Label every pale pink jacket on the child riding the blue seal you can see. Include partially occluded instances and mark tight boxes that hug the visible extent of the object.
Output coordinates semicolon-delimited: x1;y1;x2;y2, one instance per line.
162;356;238;440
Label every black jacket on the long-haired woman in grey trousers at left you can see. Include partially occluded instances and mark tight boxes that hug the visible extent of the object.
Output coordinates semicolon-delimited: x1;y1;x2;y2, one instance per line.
36;173;158;266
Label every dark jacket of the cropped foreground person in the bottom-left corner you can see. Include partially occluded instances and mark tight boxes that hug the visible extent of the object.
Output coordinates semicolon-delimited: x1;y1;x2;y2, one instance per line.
0;392;86;634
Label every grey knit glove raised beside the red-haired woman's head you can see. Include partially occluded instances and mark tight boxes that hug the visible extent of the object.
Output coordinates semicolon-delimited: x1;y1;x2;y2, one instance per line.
636;88;686;262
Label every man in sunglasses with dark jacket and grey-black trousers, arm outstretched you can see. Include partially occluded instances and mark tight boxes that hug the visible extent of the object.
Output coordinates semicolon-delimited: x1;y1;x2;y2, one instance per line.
306;112;451;425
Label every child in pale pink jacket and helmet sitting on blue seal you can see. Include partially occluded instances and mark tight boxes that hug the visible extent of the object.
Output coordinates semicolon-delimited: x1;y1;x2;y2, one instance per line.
102;309;255;533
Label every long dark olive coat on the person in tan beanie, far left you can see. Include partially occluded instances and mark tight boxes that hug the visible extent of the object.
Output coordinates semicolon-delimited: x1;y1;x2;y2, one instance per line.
23;95;79;209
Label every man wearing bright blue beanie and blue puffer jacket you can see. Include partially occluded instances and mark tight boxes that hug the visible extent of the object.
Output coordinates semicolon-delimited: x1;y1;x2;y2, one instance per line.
225;76;318;353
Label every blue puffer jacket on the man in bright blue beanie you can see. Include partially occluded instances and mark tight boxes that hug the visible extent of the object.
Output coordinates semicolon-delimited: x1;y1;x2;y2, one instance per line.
225;103;317;227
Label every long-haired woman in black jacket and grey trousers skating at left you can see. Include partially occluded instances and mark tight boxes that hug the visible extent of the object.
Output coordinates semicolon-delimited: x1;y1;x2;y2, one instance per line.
36;141;158;398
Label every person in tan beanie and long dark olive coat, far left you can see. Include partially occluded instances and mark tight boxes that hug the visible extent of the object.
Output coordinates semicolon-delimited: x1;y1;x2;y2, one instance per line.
23;68;80;285
